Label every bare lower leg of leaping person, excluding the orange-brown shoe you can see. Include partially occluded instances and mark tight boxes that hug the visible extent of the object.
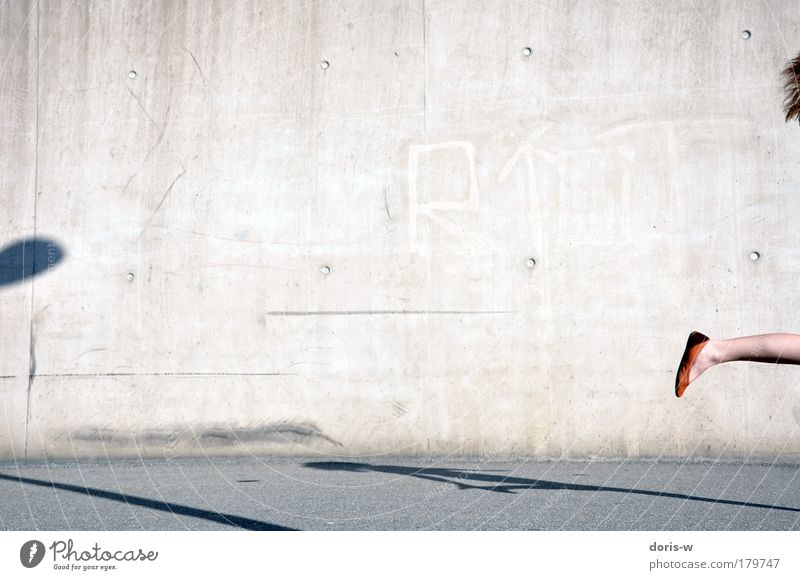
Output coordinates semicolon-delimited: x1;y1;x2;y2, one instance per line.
689;332;800;383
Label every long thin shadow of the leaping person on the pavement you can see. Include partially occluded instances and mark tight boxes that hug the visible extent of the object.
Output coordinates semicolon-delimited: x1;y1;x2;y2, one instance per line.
303;461;800;512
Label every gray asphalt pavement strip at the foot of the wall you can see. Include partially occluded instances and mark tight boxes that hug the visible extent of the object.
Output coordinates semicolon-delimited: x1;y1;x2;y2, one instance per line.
0;457;800;530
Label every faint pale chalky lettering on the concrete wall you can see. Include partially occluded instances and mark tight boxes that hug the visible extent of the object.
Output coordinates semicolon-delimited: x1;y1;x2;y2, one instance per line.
408;117;763;254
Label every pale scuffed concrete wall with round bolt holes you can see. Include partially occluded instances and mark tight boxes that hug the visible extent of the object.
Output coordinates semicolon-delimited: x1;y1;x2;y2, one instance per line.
0;0;800;461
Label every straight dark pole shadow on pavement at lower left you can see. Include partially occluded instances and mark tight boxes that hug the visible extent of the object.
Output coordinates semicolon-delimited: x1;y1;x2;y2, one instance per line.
0;473;296;532
